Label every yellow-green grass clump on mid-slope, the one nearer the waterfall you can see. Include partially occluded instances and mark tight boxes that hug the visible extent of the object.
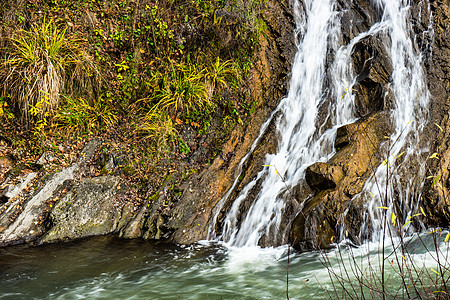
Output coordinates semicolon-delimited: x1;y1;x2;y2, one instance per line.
139;56;238;148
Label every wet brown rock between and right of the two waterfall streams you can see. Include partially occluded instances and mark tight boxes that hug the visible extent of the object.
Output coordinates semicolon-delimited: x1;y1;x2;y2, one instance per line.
290;1;449;250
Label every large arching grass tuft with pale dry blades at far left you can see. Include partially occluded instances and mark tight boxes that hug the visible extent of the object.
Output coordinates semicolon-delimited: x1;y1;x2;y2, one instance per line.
0;20;92;126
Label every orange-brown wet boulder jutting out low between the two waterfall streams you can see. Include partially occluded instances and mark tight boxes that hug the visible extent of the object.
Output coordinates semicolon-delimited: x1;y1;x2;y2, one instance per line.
289;112;391;251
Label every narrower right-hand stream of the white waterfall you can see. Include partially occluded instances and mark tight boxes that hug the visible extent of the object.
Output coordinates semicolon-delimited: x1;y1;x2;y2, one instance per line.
358;0;430;240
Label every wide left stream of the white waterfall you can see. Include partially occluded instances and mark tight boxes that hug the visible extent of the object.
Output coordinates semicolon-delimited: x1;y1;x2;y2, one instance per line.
212;0;350;246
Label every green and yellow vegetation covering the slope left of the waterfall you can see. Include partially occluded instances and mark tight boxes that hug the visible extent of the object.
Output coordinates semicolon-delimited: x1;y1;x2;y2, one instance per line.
0;0;265;190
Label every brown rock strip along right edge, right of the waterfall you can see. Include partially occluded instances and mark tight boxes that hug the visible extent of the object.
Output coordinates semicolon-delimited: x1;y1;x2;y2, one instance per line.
413;0;450;227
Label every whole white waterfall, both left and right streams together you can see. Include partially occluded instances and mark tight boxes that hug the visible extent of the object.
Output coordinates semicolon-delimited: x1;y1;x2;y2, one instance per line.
209;0;429;247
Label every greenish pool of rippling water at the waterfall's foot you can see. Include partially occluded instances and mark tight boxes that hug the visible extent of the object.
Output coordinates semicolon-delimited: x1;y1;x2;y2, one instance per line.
0;236;446;299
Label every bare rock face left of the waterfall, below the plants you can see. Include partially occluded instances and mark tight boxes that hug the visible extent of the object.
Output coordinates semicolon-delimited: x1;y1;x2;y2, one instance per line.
0;1;296;246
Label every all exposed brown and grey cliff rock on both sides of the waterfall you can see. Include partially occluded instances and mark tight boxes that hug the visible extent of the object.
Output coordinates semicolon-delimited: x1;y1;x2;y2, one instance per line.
0;0;450;250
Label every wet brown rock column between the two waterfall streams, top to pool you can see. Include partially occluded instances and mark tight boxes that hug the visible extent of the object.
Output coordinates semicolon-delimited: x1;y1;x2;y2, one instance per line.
289;0;393;251
